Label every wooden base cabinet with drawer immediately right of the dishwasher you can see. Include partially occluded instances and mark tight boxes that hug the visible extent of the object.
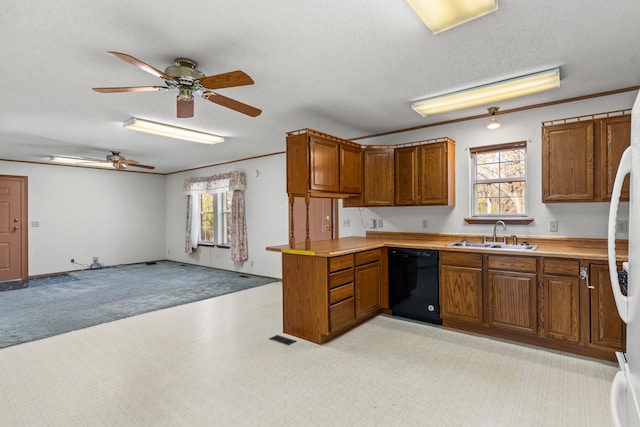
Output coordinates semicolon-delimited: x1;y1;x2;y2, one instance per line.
440;251;484;324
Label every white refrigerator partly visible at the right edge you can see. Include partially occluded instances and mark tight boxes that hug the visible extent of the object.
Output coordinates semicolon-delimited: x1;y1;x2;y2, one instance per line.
608;95;640;427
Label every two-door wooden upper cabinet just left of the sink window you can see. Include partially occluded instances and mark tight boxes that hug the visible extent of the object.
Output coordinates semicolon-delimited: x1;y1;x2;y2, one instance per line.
395;139;455;206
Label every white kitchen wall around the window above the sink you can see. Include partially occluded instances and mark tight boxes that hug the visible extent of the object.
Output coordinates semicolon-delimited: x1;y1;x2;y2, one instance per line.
336;91;636;238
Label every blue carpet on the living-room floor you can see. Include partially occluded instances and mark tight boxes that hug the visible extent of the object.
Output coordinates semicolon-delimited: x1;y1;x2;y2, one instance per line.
0;261;275;348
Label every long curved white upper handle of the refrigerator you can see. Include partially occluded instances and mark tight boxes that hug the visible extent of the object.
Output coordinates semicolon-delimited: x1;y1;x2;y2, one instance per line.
607;147;631;323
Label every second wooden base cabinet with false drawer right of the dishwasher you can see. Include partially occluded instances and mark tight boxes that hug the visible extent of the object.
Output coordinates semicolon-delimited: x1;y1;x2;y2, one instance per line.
487;255;538;335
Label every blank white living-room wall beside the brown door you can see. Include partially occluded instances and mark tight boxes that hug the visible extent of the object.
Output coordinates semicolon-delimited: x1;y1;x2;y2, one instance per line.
0;161;165;276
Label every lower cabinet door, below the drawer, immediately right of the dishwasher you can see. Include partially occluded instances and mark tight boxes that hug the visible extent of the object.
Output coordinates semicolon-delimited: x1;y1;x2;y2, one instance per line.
440;265;483;324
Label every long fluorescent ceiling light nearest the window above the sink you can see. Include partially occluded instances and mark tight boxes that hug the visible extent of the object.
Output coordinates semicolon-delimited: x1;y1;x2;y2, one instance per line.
411;68;560;117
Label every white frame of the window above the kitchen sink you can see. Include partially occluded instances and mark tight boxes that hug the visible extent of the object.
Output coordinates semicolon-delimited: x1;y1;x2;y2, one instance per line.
465;141;532;222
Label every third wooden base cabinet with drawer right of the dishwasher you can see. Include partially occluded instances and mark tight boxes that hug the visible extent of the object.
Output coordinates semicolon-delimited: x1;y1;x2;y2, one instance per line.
542;258;580;343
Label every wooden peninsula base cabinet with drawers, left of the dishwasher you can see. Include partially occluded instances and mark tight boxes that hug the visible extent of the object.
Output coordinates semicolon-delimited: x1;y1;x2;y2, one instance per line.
282;249;382;344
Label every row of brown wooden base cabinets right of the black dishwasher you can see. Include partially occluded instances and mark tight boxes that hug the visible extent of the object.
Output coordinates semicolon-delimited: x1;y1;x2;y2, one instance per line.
440;251;625;360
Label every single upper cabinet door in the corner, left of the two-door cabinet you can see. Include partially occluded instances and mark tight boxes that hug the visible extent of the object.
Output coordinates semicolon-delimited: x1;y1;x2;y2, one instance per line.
363;148;393;206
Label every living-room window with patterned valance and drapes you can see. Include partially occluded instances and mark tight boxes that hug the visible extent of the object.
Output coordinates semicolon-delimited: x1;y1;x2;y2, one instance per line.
183;172;249;262
